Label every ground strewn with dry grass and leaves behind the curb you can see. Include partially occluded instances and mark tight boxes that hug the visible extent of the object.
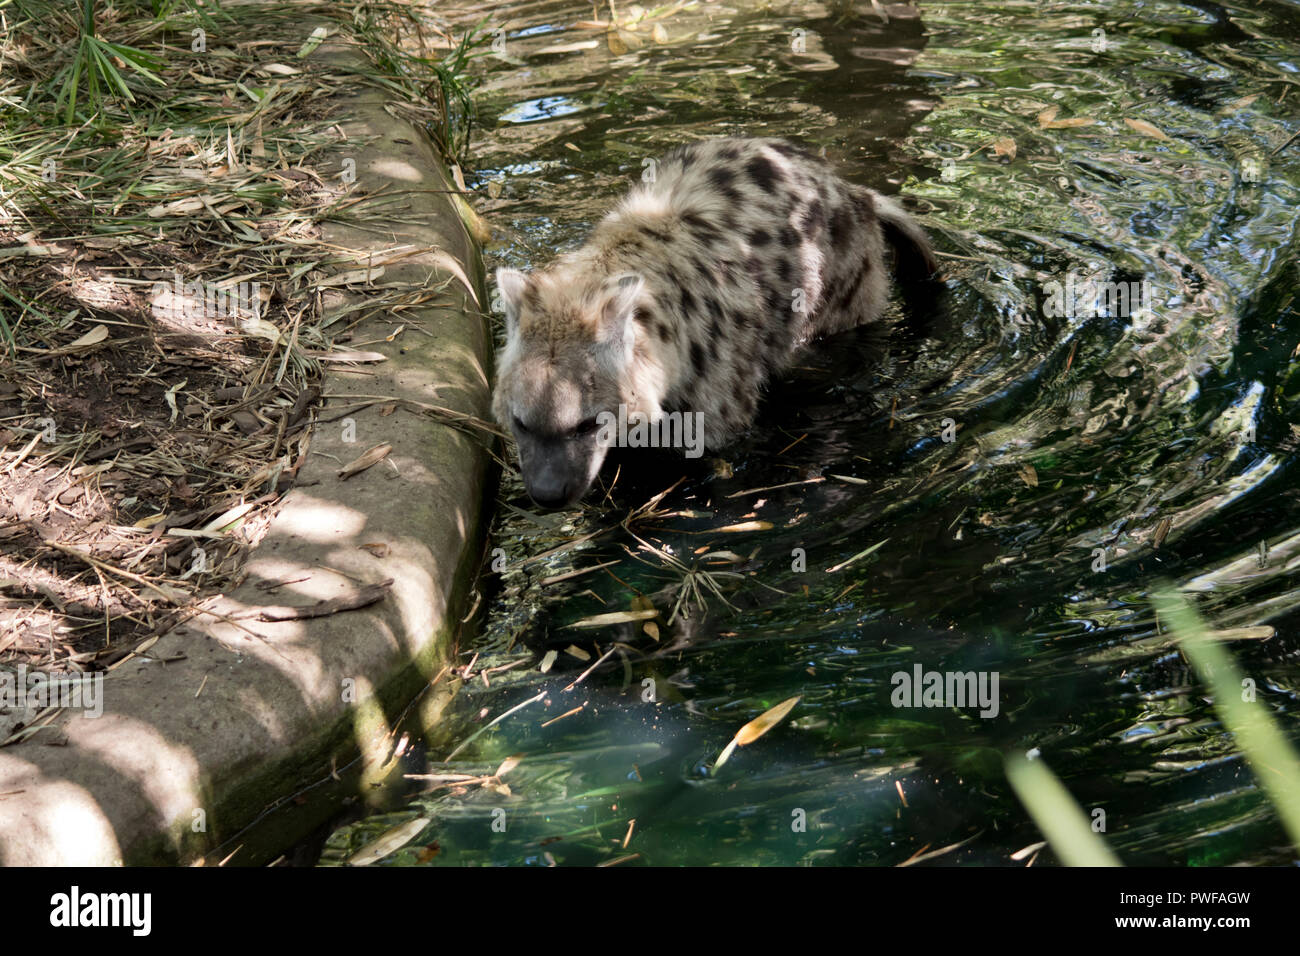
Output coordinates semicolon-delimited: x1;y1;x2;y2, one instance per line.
0;1;482;670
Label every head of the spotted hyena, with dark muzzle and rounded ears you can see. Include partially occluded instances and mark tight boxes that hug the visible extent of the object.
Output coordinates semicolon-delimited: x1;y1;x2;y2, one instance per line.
493;269;645;507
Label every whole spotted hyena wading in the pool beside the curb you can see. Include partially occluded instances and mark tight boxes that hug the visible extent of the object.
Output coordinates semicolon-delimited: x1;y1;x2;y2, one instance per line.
493;139;935;507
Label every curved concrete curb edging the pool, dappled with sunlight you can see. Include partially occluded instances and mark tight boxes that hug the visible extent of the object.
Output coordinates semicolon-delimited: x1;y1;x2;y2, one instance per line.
0;31;491;866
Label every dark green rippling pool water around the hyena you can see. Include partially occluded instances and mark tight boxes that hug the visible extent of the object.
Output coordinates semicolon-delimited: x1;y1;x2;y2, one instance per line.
324;0;1300;865
